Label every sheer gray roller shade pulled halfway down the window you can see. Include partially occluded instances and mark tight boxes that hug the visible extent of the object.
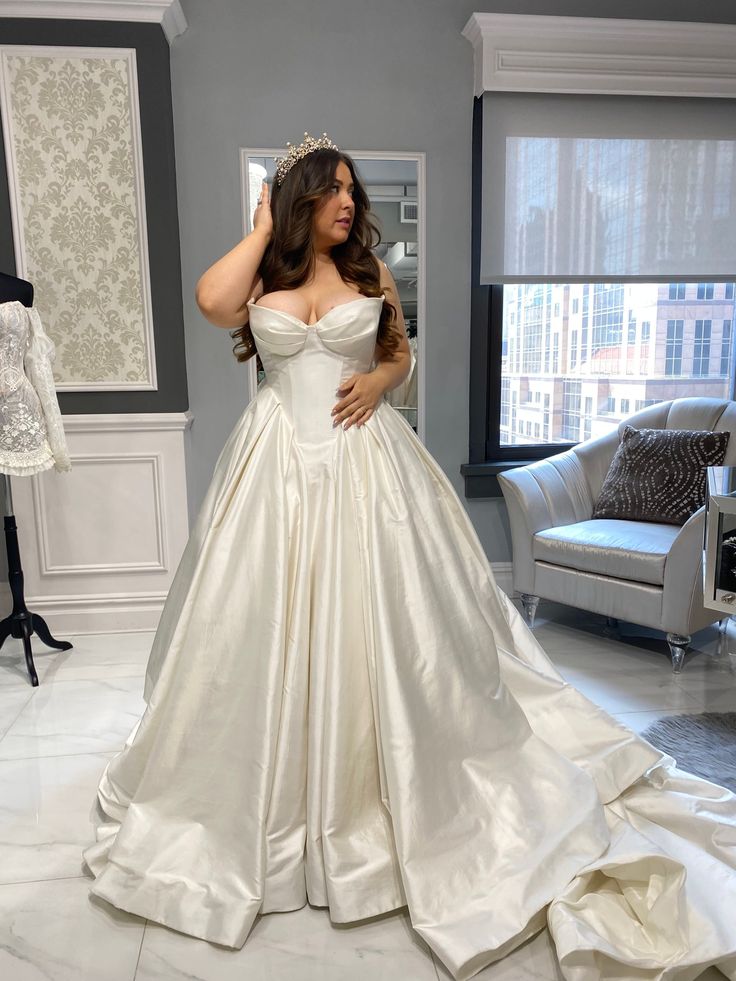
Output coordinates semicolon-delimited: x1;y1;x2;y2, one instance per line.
480;92;736;284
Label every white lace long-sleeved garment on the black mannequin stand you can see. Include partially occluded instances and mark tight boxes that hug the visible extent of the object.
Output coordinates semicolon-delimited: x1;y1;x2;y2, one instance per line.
0;300;71;476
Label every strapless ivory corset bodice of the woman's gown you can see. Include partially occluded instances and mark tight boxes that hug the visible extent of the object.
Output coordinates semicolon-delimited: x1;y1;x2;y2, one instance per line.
248;296;383;456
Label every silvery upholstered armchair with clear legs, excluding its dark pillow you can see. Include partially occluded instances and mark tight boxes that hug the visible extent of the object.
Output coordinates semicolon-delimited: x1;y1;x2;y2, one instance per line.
498;398;736;672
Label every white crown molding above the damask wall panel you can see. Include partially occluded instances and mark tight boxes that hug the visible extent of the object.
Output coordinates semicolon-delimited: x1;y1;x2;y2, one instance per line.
0;0;187;44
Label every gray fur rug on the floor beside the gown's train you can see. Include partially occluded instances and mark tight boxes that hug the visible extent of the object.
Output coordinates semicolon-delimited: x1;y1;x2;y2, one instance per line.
642;712;736;793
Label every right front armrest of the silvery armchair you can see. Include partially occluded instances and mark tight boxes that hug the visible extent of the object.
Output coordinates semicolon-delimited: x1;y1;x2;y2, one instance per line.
662;507;715;634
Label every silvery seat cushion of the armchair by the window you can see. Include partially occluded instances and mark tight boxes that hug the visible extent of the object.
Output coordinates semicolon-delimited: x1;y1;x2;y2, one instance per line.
533;518;680;586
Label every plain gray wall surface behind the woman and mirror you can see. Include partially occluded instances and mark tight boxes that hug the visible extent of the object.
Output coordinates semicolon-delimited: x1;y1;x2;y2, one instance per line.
171;0;736;562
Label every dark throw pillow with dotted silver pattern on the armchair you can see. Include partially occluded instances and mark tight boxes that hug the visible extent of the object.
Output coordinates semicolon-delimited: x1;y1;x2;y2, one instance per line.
593;426;730;525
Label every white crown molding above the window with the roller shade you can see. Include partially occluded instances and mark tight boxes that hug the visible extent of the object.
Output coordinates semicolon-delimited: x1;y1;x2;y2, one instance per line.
462;13;736;98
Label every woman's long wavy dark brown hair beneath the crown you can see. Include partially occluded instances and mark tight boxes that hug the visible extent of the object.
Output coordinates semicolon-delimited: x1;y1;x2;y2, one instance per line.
230;149;401;370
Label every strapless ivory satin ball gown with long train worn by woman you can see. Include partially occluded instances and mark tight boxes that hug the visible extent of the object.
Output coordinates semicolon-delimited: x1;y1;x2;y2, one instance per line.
84;297;736;981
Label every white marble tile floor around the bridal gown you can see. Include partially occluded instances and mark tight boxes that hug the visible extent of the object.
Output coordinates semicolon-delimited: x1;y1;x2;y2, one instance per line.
0;603;736;981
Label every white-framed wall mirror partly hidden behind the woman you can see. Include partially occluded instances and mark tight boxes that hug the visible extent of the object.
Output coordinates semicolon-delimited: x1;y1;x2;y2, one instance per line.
240;147;425;441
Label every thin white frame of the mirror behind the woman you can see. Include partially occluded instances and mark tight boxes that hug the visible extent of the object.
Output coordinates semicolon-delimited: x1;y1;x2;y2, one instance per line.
239;146;427;443
